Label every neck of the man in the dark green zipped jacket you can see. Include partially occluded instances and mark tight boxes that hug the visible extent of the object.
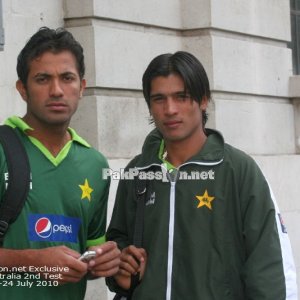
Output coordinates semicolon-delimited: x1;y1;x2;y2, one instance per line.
165;131;207;167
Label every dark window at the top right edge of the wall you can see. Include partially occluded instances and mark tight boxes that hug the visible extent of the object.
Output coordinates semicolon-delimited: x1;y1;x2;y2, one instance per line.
290;0;300;75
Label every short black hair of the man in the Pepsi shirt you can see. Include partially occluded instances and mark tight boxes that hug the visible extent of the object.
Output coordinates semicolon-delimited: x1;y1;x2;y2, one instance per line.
17;27;85;85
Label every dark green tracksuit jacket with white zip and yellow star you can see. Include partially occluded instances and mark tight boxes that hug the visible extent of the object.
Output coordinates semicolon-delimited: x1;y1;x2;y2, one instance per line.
107;130;297;300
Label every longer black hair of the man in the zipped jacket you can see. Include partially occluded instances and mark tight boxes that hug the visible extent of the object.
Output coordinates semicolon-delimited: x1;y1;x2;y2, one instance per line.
143;51;210;124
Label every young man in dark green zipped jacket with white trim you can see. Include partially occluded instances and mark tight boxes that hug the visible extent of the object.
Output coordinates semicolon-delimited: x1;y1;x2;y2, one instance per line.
107;52;297;300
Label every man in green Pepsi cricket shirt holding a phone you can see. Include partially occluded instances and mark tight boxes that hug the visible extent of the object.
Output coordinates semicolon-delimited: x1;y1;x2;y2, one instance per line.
0;27;120;300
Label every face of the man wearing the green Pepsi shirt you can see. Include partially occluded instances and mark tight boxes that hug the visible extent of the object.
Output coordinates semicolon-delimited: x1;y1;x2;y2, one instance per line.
17;51;85;128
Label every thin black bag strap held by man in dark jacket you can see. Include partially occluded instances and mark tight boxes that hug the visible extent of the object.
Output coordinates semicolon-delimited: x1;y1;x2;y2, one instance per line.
127;176;147;299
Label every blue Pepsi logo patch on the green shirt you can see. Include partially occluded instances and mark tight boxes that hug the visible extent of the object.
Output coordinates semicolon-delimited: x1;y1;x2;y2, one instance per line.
28;214;81;243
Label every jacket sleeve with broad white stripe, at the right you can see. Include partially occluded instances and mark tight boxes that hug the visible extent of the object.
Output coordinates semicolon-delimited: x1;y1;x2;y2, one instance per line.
240;160;297;300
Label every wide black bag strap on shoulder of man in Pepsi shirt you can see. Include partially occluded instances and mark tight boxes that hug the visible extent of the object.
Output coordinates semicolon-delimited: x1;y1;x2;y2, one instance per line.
0;125;30;246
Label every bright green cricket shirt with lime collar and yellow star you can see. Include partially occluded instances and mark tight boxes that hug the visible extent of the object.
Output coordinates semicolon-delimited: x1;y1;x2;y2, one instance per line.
0;118;109;300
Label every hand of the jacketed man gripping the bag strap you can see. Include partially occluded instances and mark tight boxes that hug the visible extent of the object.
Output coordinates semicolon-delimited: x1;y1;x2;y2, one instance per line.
115;245;147;290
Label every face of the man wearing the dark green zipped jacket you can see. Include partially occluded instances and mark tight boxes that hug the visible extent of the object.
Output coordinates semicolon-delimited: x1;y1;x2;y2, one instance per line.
150;74;207;142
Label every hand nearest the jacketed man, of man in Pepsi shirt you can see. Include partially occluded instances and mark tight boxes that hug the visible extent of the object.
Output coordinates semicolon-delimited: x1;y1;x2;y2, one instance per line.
88;241;121;277
